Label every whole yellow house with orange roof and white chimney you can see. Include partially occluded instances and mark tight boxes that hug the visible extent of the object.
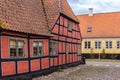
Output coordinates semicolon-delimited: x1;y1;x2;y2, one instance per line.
77;9;120;59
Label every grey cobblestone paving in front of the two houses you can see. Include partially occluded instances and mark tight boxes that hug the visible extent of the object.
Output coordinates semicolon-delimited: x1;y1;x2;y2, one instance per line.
33;60;120;80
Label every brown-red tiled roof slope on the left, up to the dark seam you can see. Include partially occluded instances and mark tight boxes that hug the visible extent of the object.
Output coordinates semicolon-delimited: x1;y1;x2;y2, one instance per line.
0;0;50;36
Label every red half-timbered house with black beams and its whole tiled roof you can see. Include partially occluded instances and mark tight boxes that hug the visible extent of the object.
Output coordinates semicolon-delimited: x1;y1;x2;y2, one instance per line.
0;0;82;78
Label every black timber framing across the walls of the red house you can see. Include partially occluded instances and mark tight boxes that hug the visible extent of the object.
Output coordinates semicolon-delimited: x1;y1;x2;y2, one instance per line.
0;14;83;78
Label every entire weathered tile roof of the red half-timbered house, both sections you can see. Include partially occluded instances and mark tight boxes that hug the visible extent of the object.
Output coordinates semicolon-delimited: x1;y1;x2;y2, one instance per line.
0;0;78;36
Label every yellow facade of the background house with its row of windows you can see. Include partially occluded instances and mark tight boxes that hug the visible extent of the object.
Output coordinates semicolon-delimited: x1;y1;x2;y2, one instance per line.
82;38;120;54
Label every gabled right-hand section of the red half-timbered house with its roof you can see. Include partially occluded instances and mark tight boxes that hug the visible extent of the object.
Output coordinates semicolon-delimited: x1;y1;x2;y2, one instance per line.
43;0;81;66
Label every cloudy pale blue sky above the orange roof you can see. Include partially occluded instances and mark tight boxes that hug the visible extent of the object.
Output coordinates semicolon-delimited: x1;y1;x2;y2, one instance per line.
67;0;120;15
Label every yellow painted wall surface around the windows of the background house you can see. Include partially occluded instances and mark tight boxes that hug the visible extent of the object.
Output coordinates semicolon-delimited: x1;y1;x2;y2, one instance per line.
82;38;120;54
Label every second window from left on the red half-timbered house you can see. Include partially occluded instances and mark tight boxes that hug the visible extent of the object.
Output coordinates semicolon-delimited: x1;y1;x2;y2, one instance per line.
33;41;44;56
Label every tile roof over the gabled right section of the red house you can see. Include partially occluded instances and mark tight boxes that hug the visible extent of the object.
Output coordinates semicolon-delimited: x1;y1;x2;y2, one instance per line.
43;0;79;27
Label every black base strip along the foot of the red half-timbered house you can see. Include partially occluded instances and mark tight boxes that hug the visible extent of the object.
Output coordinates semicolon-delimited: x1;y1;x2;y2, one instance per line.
0;61;84;80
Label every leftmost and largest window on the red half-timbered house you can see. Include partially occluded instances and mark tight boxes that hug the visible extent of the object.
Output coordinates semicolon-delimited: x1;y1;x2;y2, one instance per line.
10;40;24;57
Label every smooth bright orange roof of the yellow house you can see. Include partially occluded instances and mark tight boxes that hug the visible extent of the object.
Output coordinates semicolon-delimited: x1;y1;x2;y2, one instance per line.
78;12;120;38
